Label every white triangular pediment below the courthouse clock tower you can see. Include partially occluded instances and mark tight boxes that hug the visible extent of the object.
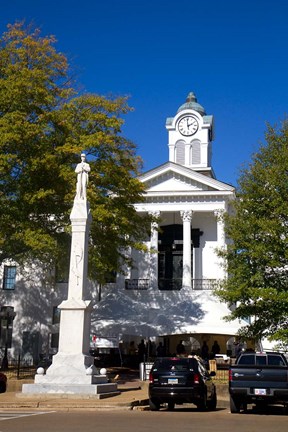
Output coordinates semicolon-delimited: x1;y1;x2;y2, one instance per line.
139;162;234;193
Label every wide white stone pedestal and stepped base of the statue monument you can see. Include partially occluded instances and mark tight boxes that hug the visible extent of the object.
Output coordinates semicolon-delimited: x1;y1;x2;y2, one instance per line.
22;299;119;397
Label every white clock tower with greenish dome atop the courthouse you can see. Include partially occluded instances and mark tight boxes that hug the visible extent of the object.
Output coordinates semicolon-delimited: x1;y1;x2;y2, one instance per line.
166;92;214;178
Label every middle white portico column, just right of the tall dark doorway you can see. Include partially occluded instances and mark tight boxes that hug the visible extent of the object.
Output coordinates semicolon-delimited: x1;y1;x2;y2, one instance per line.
180;210;193;288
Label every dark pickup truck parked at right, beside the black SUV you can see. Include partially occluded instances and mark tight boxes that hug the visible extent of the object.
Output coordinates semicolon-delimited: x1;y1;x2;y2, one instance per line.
229;352;288;414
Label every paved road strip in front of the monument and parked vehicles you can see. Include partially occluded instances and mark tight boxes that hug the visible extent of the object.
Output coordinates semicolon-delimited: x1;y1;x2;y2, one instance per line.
0;408;287;432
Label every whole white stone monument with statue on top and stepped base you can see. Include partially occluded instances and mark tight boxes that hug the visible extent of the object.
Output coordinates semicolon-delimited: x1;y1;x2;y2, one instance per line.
22;154;118;397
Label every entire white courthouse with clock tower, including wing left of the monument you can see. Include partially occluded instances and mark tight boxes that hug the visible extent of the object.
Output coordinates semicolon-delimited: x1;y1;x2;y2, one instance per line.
0;93;245;359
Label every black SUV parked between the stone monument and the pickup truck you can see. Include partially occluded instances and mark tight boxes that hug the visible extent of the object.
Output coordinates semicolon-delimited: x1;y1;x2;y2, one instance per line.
149;356;217;411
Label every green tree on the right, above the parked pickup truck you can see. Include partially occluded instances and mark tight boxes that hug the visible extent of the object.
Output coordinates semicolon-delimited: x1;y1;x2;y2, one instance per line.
217;121;288;340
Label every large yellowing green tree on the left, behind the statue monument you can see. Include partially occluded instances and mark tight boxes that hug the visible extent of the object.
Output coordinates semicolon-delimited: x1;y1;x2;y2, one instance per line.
0;22;151;282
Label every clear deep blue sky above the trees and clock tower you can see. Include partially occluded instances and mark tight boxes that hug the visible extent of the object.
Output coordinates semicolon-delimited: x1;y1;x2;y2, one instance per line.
0;0;288;185
